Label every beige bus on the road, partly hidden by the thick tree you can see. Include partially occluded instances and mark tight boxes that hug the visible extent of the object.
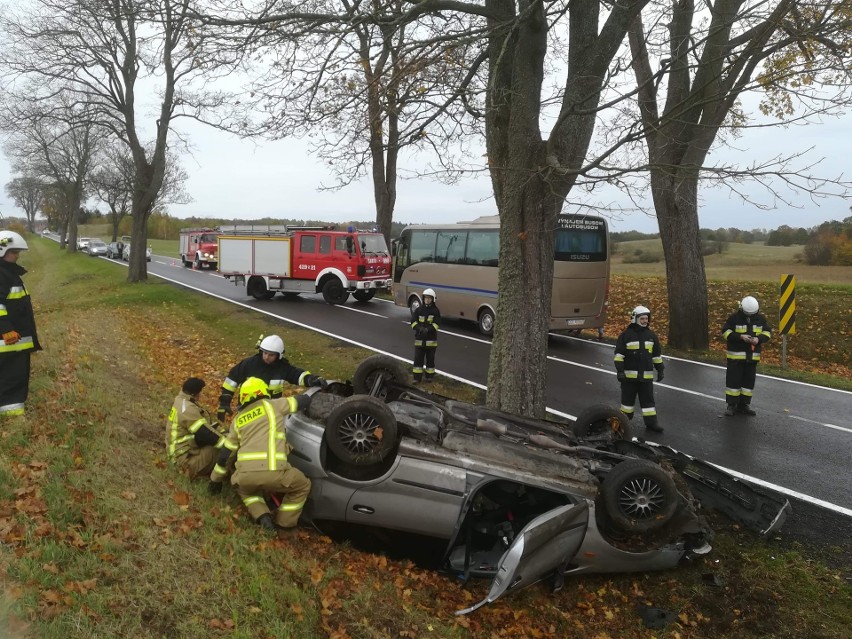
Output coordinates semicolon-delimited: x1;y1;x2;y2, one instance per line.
393;215;610;335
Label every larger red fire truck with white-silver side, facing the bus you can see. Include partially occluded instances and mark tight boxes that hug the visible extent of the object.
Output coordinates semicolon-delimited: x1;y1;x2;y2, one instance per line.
219;225;392;304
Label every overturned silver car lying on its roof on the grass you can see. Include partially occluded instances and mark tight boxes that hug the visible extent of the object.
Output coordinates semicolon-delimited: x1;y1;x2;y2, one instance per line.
287;355;790;614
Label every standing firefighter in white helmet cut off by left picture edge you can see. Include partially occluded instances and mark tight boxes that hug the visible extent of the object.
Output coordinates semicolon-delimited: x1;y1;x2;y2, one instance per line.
0;231;41;417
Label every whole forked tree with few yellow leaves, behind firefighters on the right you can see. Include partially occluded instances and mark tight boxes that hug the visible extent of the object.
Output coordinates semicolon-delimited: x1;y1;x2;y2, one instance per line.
629;0;852;349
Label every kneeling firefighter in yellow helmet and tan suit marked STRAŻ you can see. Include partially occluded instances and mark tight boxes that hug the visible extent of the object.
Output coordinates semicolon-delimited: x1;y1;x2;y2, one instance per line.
209;377;311;531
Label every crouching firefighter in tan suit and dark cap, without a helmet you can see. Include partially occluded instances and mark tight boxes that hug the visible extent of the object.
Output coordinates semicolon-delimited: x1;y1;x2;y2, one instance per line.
166;377;225;479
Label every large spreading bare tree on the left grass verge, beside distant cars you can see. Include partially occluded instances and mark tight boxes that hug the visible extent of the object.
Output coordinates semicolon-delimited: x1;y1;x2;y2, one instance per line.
0;0;223;282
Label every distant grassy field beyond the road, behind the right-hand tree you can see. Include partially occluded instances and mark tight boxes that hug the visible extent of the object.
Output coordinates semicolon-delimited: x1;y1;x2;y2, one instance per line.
612;240;852;284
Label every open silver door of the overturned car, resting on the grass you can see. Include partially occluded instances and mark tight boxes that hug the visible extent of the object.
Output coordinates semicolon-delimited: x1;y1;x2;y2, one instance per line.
456;502;589;615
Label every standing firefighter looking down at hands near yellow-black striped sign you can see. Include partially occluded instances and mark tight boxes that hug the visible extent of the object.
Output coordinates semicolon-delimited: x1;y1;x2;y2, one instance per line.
722;295;772;417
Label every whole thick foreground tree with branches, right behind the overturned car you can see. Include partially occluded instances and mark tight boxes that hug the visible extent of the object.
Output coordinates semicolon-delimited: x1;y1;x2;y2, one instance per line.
195;0;648;415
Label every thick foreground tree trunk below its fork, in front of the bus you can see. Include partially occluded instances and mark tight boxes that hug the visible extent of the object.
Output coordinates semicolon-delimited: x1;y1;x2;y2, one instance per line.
487;174;561;417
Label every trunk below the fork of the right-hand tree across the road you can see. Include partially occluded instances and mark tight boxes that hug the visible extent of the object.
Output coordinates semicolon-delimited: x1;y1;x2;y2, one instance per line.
651;169;709;350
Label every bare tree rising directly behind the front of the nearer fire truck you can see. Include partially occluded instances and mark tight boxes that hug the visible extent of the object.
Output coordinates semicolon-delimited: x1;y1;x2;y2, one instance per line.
199;0;485;245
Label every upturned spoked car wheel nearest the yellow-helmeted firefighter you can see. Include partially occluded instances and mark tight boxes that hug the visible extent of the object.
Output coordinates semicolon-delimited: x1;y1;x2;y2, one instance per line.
325;395;397;466
